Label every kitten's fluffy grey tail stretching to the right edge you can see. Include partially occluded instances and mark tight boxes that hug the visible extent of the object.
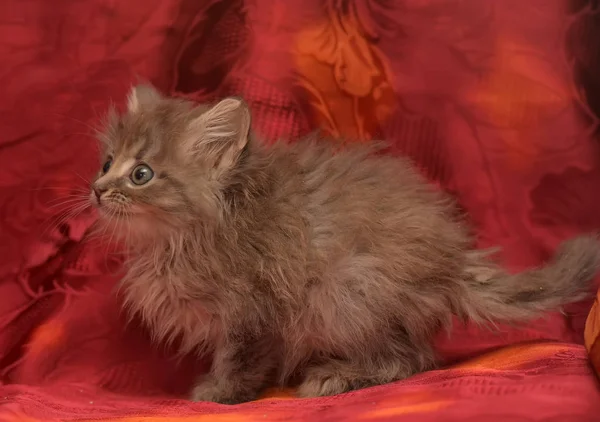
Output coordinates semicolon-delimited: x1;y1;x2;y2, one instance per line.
458;236;600;322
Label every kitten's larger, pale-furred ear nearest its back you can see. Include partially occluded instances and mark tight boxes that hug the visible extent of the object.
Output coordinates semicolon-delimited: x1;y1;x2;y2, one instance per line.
188;97;251;168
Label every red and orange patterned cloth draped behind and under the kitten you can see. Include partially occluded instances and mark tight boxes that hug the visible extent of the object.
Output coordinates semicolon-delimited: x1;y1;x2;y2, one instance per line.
0;0;600;422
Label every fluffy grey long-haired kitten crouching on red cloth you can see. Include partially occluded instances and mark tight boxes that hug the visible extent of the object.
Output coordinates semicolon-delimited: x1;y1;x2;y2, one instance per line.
91;86;600;403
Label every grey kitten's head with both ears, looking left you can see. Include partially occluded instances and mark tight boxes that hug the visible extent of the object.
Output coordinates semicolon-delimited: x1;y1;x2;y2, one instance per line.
90;85;250;241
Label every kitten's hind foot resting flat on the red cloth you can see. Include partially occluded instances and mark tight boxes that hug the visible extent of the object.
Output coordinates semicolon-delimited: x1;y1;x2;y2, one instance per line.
298;345;435;397
